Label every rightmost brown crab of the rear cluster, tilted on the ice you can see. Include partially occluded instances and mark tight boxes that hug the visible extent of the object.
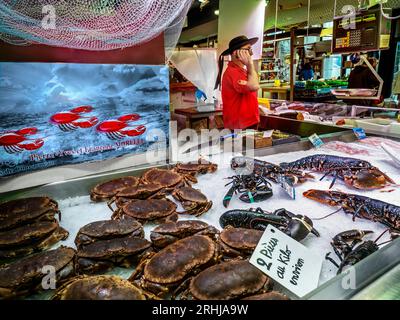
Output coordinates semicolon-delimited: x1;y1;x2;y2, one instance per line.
172;187;212;217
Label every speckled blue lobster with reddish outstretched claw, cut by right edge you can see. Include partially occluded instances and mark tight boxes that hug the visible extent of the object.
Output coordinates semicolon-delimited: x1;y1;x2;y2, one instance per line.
303;189;400;232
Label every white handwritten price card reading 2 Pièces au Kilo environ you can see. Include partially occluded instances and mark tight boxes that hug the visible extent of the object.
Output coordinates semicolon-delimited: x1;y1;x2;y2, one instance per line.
250;225;323;298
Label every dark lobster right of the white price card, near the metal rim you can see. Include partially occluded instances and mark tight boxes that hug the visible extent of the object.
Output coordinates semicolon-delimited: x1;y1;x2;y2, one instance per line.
325;230;387;274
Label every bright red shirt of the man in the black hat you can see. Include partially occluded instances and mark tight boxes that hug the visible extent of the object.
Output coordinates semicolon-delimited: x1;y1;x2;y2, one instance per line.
221;61;260;130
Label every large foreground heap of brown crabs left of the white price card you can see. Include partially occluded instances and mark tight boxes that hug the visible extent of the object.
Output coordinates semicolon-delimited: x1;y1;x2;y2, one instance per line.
0;218;288;300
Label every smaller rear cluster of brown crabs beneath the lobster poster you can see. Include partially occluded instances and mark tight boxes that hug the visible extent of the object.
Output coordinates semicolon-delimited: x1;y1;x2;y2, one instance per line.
90;159;217;224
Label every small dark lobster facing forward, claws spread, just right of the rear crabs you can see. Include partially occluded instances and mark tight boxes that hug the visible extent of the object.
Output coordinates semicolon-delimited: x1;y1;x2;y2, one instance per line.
223;173;273;208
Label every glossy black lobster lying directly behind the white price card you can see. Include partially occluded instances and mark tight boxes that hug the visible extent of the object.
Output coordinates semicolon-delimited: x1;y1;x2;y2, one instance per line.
219;208;320;241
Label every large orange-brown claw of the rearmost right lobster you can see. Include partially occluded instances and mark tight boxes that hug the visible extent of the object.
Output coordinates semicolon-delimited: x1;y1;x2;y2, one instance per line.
344;168;395;189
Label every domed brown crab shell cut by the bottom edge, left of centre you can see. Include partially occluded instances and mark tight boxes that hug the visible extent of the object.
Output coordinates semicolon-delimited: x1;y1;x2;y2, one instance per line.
52;275;146;300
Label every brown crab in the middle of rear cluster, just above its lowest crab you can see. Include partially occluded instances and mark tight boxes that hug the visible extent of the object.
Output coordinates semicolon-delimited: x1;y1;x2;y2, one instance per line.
107;183;165;211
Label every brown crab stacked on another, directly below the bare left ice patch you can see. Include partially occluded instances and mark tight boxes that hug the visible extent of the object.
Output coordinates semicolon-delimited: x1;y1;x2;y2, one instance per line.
75;218;144;248
